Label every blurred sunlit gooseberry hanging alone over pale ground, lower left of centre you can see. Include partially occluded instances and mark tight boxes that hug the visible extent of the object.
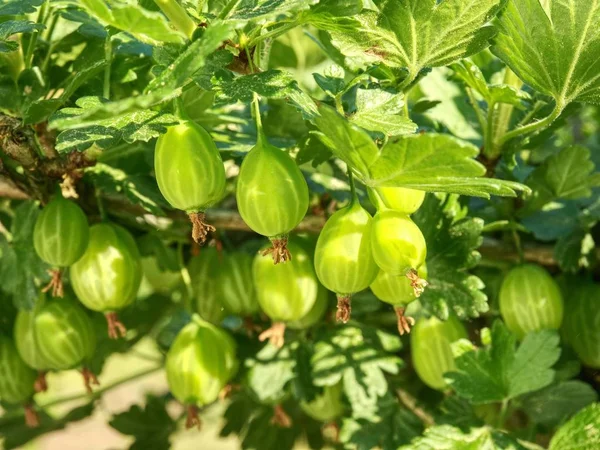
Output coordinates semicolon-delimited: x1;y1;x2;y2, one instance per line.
166;316;238;406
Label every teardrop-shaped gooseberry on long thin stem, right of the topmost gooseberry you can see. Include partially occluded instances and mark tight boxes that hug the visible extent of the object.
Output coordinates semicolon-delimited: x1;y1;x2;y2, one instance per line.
236;130;308;264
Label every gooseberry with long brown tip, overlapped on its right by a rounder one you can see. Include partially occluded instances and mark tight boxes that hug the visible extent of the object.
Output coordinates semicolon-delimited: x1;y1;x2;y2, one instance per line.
315;199;379;323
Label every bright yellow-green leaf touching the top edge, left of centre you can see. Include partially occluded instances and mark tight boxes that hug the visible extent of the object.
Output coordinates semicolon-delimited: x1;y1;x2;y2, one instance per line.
79;0;185;44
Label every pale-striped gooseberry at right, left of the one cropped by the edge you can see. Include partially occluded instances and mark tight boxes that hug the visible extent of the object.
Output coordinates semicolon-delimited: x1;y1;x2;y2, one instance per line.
499;264;563;339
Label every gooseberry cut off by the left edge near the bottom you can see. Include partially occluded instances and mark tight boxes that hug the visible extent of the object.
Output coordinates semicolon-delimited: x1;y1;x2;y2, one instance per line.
0;336;36;404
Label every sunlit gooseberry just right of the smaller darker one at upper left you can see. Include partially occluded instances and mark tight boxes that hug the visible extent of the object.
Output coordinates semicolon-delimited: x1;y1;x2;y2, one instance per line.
70;223;142;312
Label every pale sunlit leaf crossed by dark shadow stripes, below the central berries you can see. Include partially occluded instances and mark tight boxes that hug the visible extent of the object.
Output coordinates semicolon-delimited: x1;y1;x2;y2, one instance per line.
312;325;402;419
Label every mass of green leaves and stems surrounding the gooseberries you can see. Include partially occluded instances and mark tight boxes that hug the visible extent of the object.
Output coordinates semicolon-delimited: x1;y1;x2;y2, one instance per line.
0;0;600;449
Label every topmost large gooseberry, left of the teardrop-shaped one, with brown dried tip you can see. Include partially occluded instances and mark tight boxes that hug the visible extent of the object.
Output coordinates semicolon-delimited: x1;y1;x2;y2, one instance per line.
154;120;225;243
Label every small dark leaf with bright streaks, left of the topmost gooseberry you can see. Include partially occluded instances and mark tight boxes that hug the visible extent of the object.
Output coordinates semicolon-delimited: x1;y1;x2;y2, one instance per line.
85;162;166;215
